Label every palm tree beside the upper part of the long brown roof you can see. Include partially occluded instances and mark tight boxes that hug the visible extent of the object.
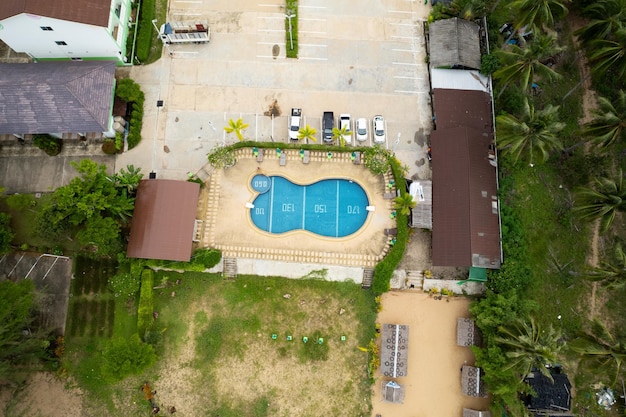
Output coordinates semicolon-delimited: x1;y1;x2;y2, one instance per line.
496;99;565;164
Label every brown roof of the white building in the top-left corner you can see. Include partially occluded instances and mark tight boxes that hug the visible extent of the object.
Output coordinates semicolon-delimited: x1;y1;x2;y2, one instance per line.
0;0;111;27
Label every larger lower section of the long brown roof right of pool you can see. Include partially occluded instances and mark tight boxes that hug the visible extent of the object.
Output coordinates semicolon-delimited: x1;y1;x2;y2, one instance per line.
431;127;501;268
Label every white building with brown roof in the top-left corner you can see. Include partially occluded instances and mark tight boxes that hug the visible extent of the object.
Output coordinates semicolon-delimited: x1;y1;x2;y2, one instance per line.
0;0;133;64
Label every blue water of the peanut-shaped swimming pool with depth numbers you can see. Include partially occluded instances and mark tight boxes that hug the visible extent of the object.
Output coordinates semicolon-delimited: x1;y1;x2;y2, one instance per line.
250;175;369;237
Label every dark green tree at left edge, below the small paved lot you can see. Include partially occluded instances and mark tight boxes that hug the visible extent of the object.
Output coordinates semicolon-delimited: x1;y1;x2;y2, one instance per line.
0;279;48;387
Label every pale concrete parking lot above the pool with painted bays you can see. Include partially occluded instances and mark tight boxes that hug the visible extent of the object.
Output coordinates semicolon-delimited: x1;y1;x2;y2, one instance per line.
117;0;432;179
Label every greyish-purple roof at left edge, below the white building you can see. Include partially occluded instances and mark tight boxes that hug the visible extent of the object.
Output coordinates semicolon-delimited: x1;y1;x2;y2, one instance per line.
0;61;115;134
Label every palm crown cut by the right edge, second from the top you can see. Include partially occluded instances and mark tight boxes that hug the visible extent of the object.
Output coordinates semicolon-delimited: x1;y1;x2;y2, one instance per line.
589;28;626;79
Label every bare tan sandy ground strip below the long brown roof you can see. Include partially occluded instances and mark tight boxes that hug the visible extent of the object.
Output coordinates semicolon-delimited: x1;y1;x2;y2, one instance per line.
372;292;489;417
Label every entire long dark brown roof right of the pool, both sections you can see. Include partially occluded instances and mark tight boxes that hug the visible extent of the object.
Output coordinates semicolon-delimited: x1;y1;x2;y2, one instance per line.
431;89;502;268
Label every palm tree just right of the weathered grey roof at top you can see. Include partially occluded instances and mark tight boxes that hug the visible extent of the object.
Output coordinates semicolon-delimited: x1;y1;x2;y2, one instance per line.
493;35;563;91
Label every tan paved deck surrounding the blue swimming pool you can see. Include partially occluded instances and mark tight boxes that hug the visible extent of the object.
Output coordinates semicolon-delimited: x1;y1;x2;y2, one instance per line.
198;148;396;268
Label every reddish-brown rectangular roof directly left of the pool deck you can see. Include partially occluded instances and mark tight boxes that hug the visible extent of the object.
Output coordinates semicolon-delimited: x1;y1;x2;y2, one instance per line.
127;179;200;262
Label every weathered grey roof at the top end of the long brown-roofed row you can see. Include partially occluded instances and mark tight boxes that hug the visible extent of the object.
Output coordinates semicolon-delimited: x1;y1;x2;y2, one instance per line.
428;17;480;69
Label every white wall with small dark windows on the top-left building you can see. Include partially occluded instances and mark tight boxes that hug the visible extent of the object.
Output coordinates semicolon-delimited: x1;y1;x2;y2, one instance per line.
0;13;123;60
